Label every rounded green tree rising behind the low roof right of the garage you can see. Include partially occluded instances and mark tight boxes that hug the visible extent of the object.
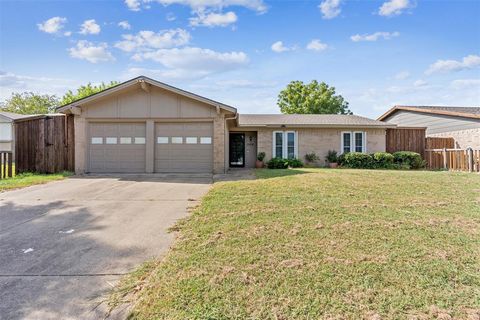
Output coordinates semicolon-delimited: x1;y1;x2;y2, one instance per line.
277;80;352;114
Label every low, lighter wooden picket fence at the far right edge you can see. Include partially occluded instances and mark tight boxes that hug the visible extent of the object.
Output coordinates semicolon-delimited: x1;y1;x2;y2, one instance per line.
425;148;480;172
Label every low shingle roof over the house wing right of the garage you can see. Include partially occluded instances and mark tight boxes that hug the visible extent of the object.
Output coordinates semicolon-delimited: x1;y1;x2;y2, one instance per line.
238;114;392;127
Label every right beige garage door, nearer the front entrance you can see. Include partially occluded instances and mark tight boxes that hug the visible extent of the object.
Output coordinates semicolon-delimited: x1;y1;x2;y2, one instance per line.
155;122;213;172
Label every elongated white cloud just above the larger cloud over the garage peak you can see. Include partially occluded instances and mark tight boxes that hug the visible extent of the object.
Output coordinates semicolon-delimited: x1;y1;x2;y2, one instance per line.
115;29;191;52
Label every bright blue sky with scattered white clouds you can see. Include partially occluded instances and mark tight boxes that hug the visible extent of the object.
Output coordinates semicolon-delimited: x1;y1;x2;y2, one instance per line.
0;0;480;118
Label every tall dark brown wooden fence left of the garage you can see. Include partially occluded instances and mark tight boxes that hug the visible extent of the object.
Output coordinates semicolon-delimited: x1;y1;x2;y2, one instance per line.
15;114;75;173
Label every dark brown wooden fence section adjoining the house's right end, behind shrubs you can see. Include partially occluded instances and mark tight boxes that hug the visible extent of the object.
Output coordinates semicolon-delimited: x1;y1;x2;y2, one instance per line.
385;127;425;155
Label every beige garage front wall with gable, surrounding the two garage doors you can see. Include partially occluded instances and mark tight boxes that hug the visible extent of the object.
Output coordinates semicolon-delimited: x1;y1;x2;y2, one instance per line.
75;82;229;174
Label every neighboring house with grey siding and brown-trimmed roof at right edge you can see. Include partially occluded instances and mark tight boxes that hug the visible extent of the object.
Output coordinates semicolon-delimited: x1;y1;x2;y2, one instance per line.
378;106;480;149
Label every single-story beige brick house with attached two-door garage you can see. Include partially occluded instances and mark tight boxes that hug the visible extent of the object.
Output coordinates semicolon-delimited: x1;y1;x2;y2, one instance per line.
58;76;395;173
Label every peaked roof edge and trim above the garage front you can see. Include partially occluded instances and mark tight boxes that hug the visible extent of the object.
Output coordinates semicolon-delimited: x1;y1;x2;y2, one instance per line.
57;76;237;113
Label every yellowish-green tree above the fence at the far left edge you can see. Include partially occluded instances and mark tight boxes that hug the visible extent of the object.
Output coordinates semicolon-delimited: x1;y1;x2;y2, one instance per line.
0;92;58;114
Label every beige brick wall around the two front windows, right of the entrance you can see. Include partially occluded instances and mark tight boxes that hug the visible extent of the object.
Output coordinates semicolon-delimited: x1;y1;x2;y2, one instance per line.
257;128;386;163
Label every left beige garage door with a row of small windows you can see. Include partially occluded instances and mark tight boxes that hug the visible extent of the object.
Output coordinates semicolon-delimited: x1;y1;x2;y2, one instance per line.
88;122;145;173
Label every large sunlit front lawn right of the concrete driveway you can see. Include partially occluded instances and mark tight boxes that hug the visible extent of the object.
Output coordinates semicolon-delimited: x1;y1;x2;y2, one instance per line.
110;169;480;319
